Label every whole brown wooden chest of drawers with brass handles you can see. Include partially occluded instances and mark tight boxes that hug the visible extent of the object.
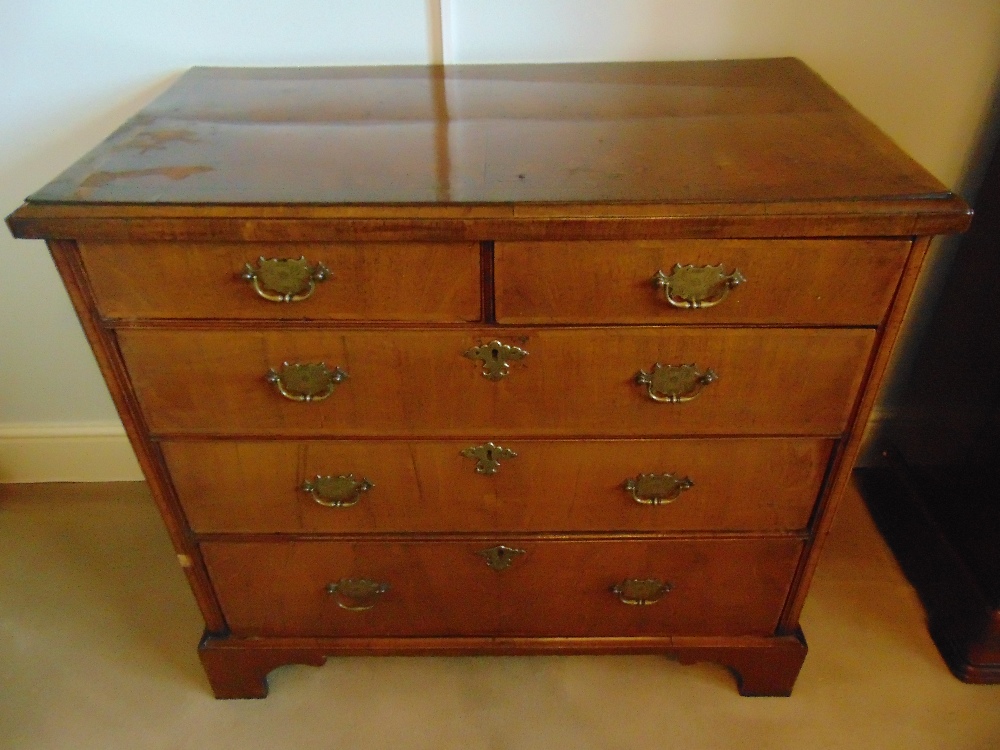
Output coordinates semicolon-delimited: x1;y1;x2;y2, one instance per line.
8;60;968;697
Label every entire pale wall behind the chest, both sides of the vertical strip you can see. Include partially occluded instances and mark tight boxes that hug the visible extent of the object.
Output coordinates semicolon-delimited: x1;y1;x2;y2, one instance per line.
0;0;1000;481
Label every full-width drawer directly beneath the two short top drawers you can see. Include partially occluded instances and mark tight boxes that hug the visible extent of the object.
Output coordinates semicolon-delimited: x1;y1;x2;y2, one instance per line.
118;327;875;442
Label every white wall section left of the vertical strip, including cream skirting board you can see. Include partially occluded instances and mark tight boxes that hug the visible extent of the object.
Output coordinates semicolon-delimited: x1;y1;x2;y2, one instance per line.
0;0;428;482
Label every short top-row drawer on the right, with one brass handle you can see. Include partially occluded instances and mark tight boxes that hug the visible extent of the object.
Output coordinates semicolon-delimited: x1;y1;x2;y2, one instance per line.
494;240;910;326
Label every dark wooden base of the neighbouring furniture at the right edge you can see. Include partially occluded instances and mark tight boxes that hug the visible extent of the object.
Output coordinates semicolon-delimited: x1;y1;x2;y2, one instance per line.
854;449;1000;684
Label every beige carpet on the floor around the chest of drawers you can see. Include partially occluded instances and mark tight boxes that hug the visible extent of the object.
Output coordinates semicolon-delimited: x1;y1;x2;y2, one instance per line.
0;484;1000;750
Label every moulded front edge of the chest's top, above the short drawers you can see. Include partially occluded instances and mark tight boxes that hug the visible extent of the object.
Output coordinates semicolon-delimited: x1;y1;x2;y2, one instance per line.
7;201;971;242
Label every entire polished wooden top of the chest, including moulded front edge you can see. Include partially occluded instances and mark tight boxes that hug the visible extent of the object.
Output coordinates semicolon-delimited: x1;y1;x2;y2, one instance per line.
7;59;969;241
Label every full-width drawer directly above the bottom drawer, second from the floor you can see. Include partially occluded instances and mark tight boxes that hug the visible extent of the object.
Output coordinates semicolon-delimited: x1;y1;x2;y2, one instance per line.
168;438;832;533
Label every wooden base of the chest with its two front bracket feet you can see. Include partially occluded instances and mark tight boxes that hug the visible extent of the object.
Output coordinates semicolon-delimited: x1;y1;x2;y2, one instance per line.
198;630;808;698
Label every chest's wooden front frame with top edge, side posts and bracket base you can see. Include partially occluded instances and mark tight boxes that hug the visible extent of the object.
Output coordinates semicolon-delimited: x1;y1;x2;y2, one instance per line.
7;63;971;698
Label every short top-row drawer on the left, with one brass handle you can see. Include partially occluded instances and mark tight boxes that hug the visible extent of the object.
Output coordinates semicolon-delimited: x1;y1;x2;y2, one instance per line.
80;242;481;321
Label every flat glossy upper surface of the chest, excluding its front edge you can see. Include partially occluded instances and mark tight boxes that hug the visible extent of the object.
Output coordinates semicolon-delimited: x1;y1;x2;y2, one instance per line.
23;59;960;204
